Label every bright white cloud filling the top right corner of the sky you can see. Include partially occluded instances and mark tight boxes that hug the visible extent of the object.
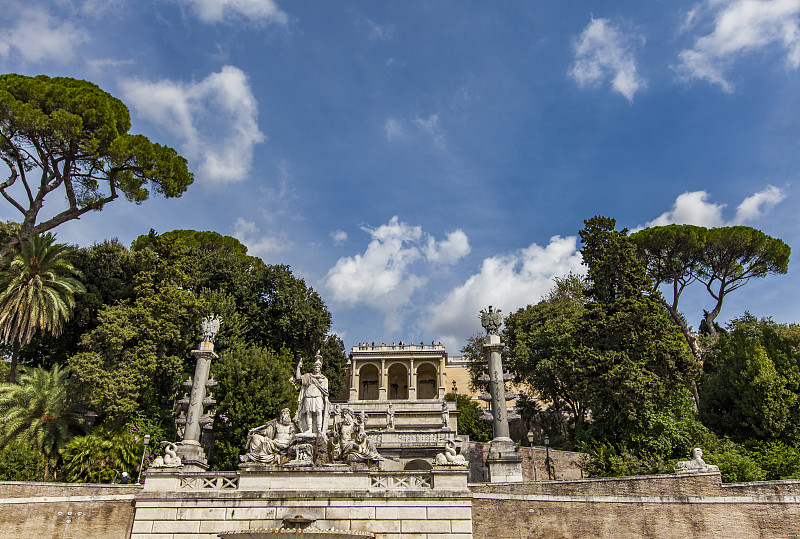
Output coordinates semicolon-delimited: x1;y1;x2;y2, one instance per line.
677;0;800;92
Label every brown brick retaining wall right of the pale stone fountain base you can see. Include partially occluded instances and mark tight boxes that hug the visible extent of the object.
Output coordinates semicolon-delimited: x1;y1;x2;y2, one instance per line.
470;474;800;539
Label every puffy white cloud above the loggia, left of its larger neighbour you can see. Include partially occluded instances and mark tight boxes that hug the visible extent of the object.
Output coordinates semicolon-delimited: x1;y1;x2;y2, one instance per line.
324;216;470;316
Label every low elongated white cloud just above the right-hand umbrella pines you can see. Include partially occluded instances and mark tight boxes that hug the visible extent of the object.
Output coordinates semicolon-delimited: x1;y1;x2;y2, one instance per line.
646;185;786;228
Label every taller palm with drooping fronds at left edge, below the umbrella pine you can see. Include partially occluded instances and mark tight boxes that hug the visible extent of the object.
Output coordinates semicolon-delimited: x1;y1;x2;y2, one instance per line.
0;232;85;382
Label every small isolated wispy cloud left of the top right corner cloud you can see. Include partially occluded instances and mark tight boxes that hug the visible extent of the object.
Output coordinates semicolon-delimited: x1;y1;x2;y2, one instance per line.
569;19;646;101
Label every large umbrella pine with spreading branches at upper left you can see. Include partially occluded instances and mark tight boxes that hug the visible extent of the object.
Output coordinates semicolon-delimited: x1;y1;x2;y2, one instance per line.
0;74;193;243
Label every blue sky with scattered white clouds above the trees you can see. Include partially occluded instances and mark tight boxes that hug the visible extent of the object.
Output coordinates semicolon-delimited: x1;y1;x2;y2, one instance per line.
0;0;800;354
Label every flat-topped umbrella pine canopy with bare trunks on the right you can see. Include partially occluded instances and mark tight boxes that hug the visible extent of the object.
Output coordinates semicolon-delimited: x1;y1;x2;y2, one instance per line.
631;225;791;344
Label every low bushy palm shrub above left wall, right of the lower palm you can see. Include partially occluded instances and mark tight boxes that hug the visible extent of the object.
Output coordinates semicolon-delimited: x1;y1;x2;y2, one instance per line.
64;426;144;483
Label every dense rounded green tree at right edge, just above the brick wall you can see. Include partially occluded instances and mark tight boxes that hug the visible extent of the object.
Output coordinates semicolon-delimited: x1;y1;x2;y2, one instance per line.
700;314;800;443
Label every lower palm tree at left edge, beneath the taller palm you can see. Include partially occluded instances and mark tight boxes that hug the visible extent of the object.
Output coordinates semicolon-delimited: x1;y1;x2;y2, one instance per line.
0;365;78;476
